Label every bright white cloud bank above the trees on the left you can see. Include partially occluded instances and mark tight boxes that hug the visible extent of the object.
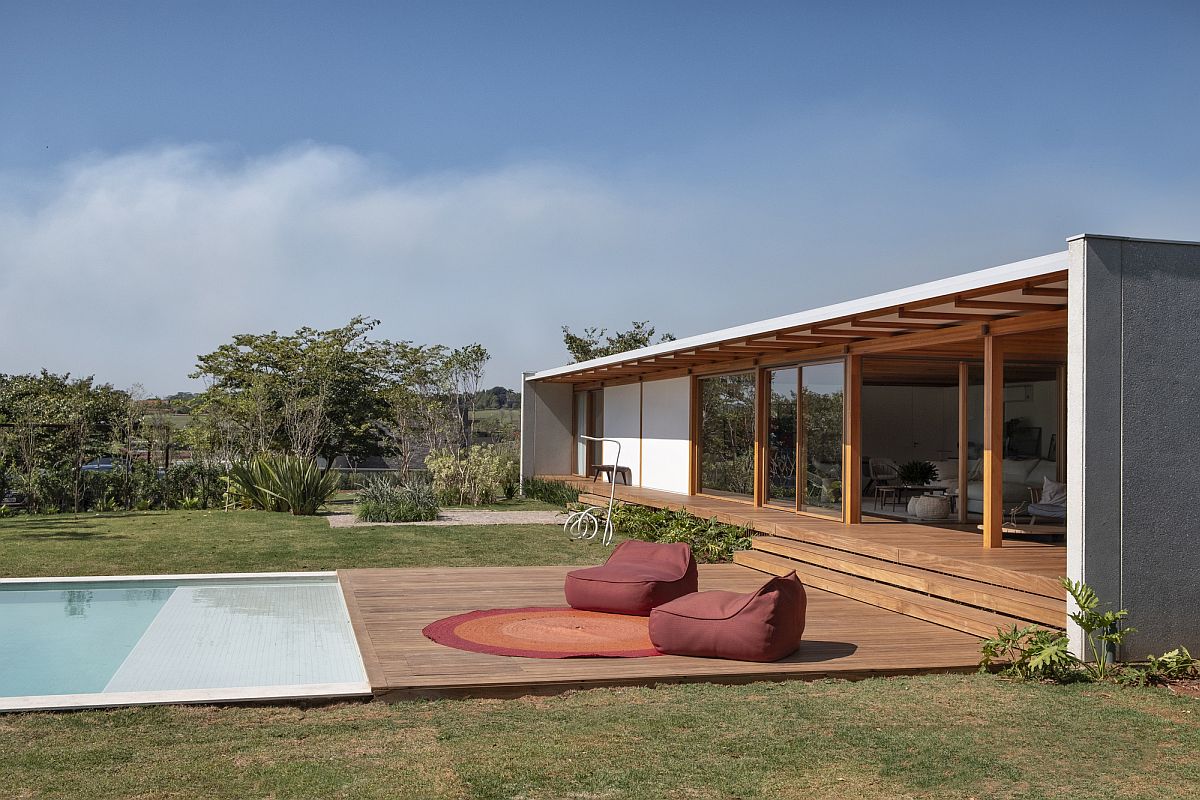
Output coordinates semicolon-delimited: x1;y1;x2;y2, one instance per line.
0;145;676;391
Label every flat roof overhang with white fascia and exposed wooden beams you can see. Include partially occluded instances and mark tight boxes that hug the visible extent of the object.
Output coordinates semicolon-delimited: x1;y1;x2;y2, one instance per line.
529;251;1068;385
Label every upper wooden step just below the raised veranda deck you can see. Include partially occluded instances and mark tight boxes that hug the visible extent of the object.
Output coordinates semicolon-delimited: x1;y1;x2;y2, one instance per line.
754;536;1067;627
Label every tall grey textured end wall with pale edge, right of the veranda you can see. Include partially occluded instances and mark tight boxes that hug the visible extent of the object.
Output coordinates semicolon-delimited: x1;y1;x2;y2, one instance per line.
1067;235;1200;658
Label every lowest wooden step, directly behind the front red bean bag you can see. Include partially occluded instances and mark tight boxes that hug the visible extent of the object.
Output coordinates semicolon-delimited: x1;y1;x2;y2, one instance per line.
733;551;1056;638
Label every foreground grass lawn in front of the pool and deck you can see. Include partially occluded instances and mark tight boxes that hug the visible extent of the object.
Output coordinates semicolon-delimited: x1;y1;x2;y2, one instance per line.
0;675;1200;800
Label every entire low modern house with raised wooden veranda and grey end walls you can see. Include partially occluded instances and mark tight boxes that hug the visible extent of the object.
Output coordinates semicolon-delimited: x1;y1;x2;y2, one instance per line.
521;235;1200;657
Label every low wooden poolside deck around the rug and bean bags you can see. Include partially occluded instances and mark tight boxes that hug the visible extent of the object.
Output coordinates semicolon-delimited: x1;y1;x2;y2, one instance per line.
337;565;979;699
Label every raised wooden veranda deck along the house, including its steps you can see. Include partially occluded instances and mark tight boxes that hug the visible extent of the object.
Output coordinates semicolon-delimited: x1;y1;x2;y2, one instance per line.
549;477;1067;637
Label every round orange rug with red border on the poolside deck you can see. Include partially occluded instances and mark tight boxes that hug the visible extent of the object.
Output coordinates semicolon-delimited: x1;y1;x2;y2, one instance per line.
421;608;662;658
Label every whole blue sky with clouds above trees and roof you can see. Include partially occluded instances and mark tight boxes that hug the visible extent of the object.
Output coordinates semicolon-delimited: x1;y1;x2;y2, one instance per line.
0;0;1200;391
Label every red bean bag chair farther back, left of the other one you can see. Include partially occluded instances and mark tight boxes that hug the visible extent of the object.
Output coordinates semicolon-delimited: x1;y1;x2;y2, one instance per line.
563;539;696;616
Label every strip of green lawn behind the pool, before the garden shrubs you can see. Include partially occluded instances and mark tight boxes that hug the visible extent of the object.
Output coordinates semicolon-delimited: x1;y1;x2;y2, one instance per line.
0;511;608;578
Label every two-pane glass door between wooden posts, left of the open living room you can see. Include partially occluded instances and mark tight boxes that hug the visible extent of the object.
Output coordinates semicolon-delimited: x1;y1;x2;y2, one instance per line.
766;361;845;518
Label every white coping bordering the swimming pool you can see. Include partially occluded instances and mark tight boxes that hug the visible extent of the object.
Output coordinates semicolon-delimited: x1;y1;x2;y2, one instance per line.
0;570;372;714
